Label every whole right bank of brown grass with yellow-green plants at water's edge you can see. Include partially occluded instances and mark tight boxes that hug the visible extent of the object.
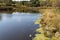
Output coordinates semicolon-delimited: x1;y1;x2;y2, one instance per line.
33;9;60;40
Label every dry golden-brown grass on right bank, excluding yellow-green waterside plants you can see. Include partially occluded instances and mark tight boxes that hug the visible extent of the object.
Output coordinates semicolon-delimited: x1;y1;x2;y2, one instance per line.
33;9;60;40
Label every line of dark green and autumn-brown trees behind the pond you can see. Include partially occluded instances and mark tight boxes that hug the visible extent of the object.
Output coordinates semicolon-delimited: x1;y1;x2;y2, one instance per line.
0;0;60;7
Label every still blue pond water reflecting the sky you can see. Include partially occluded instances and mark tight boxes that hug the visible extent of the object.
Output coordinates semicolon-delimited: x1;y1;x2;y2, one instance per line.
0;12;39;40
